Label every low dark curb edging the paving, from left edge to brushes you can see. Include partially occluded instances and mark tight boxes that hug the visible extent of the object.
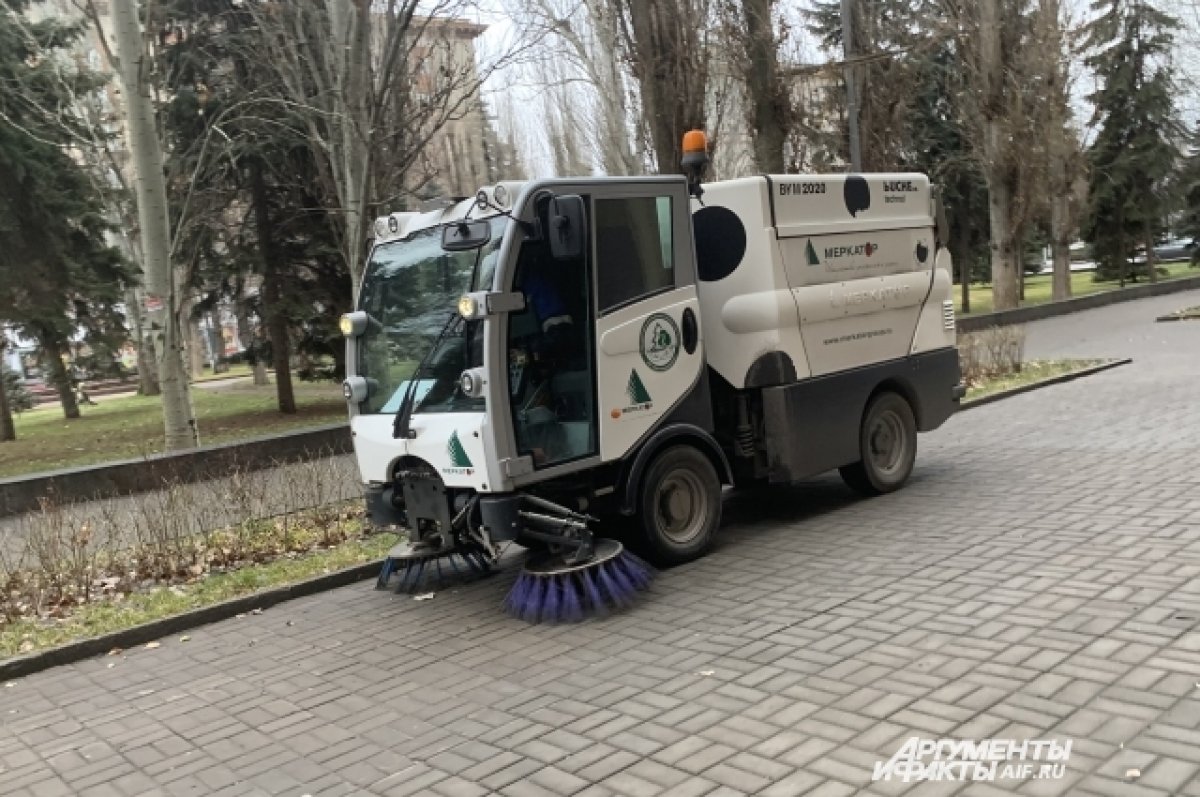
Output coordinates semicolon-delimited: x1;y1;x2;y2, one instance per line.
0;559;383;681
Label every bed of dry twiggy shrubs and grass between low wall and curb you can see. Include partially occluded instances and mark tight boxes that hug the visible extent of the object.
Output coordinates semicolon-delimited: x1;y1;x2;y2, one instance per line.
0;459;379;655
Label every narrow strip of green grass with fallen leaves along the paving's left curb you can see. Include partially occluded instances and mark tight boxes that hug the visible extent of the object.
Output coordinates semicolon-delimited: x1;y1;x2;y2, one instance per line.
0;534;396;658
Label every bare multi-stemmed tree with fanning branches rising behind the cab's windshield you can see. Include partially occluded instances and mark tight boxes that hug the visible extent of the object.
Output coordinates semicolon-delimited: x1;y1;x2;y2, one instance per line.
250;0;515;292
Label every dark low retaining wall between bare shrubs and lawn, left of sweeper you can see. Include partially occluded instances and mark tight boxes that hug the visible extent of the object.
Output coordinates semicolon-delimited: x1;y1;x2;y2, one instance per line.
0;424;353;517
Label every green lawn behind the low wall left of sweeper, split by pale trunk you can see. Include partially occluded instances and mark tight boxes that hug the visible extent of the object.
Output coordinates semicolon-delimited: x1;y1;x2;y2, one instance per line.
0;379;347;477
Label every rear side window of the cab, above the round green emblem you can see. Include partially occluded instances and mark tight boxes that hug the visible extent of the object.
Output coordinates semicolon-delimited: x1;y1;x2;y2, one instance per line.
595;197;674;313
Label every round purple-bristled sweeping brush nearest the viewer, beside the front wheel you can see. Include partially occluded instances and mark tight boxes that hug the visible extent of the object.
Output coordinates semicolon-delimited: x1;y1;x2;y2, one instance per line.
504;539;654;623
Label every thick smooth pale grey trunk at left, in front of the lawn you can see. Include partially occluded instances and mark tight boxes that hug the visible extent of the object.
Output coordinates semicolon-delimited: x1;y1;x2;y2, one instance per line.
112;0;200;450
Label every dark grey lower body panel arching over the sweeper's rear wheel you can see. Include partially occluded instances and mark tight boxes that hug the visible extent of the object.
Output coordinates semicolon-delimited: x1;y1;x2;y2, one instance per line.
762;348;959;484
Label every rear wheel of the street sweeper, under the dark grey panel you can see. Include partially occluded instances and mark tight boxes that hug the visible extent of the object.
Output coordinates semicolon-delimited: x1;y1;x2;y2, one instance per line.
838;392;917;496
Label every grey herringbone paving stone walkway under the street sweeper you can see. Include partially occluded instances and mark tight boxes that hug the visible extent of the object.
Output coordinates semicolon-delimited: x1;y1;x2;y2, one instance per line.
0;292;1200;797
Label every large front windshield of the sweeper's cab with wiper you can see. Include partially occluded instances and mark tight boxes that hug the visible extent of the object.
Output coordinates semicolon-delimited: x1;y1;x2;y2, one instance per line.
358;216;508;413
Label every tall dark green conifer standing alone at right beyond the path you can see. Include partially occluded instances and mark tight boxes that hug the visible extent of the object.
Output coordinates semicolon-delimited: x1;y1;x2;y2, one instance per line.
1082;0;1182;286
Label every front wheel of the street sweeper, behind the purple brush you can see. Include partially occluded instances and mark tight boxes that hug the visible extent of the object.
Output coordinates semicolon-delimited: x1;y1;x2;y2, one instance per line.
637;445;721;567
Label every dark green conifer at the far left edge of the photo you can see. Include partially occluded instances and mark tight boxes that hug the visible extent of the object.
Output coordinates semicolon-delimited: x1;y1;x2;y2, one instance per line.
0;0;137;418
